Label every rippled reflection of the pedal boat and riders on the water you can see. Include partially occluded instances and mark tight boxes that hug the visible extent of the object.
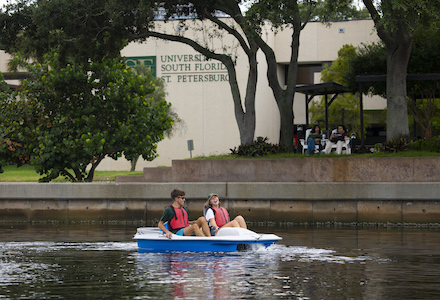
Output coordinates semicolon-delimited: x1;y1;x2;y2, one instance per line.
136;247;281;299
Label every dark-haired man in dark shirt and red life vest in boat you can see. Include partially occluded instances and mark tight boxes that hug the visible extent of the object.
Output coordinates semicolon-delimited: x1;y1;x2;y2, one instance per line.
158;189;211;238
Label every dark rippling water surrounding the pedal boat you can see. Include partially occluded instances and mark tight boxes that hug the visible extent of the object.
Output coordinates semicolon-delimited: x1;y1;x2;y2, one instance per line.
0;225;440;299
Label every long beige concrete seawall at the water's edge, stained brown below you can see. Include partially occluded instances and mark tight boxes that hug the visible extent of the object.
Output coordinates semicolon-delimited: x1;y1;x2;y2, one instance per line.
0;182;440;226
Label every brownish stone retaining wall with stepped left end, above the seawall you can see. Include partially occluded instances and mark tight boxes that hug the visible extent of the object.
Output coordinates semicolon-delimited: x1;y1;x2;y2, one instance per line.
116;156;440;182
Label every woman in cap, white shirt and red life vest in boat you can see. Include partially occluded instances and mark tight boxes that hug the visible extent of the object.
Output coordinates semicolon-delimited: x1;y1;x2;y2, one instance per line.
203;193;247;234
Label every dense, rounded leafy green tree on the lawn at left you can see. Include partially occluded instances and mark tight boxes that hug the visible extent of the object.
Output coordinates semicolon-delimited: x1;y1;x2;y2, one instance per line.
0;55;173;181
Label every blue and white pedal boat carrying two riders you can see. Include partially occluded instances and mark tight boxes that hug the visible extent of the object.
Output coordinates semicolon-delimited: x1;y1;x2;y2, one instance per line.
133;227;282;252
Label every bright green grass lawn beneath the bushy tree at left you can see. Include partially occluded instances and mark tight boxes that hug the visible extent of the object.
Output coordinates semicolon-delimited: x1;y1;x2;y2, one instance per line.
0;166;142;182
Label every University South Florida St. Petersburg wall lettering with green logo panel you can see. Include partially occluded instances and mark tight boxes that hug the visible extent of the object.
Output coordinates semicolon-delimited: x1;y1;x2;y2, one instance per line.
125;54;229;83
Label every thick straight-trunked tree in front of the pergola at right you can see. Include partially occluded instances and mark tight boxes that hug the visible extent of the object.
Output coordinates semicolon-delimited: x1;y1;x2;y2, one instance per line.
329;0;440;139
